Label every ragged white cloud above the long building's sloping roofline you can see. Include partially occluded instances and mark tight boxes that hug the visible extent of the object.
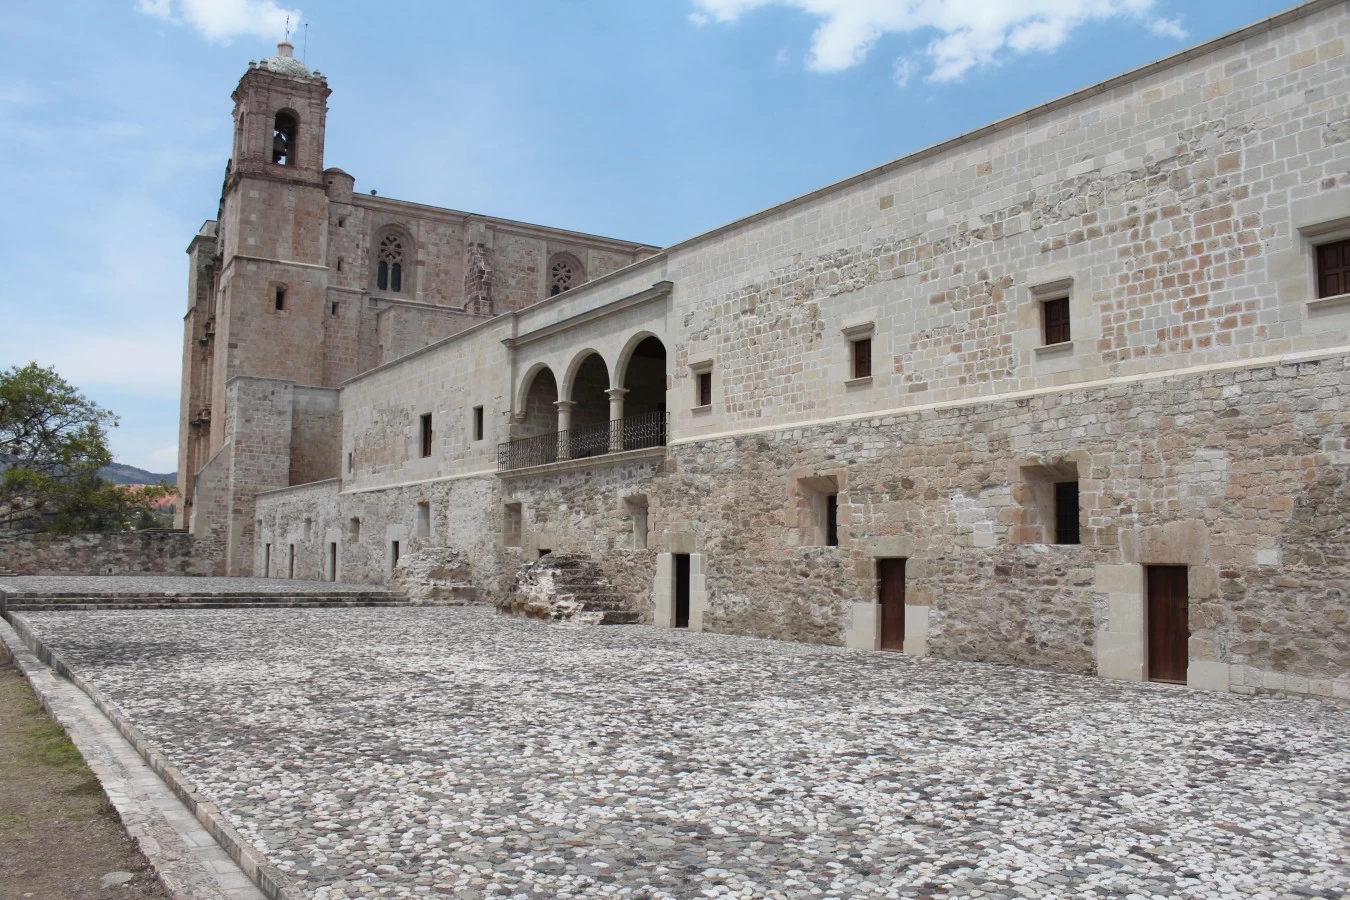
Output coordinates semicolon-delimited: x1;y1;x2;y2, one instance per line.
690;0;1185;84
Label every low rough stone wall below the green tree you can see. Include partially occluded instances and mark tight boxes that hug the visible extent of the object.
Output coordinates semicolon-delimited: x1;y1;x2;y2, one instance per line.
0;532;223;575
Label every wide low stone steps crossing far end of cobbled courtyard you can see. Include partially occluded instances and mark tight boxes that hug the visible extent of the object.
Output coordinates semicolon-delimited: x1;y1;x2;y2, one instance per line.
0;590;410;613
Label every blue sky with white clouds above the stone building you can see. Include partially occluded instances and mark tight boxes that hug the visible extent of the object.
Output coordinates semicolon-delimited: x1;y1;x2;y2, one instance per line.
0;0;1288;471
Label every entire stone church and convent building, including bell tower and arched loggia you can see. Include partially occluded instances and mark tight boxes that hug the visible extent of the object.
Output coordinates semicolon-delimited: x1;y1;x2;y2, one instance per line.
180;0;1350;699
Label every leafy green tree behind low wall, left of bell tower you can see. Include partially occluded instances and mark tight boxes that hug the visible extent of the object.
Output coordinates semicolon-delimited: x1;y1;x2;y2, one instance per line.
0;363;176;534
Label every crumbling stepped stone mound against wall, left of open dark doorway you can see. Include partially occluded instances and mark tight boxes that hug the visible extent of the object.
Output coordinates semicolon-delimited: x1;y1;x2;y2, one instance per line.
497;553;637;625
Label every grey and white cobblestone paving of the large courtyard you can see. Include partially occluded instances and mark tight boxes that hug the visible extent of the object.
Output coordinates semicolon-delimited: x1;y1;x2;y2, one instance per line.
26;609;1350;899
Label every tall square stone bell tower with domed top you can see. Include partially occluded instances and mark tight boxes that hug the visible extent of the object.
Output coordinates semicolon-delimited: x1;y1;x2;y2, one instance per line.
180;40;331;575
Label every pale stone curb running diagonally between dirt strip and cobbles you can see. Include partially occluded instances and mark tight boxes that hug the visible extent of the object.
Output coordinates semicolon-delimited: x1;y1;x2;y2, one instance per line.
4;613;304;900
